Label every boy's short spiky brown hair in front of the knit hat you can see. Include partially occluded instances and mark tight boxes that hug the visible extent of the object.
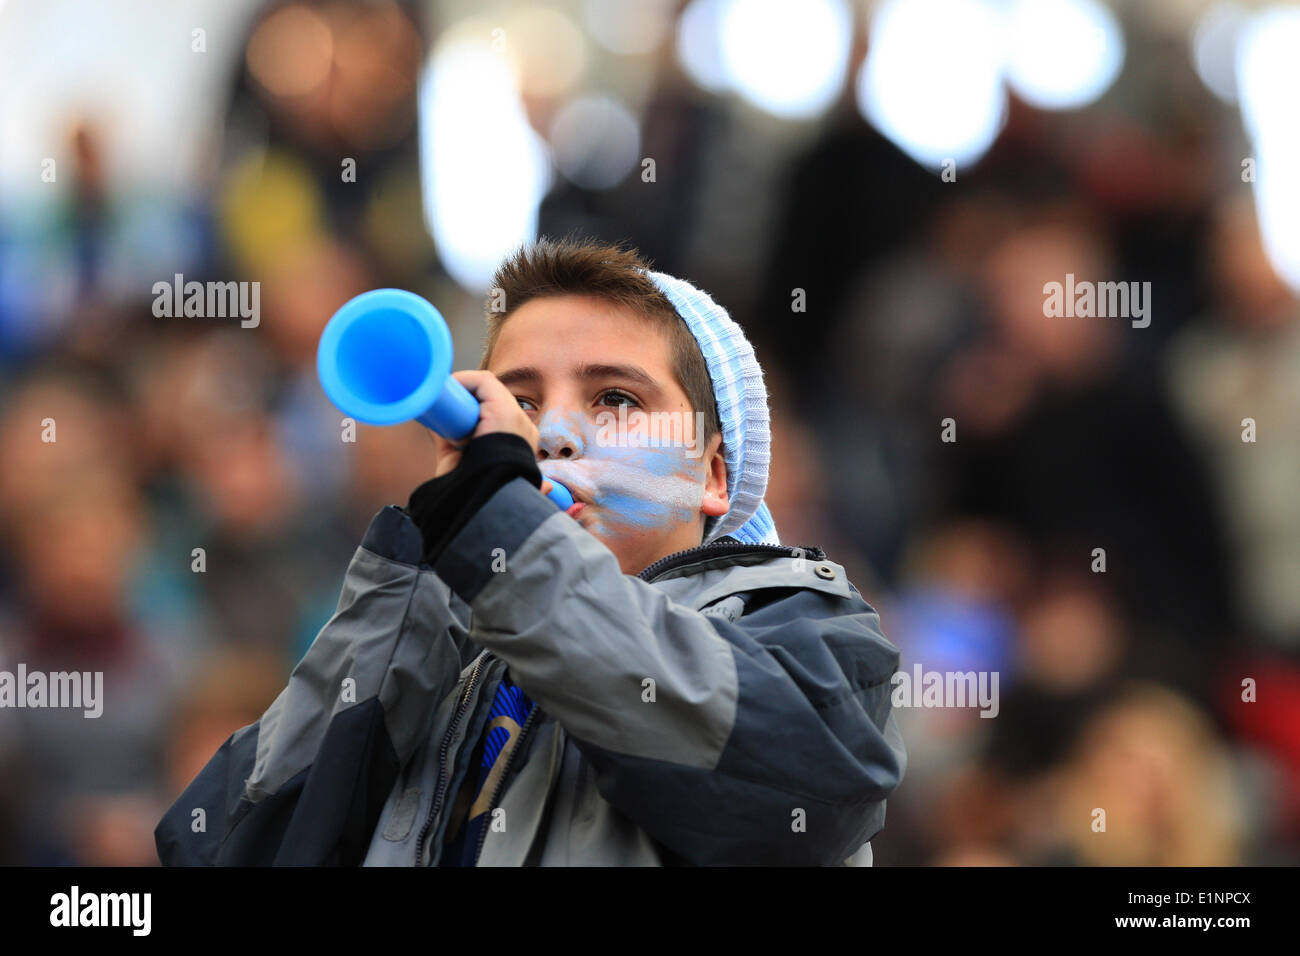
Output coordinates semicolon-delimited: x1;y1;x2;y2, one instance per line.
478;238;722;442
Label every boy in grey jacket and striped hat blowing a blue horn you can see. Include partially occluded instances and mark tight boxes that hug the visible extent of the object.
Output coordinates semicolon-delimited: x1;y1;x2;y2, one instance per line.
156;241;906;866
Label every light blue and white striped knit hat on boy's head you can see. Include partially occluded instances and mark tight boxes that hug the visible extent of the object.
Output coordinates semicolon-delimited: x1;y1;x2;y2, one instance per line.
646;272;780;545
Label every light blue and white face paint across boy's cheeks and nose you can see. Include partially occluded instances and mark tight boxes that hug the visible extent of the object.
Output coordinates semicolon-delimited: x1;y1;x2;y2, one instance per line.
537;411;707;540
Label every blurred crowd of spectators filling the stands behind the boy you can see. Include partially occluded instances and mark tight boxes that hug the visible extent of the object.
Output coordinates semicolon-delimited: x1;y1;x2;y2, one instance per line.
0;1;1300;865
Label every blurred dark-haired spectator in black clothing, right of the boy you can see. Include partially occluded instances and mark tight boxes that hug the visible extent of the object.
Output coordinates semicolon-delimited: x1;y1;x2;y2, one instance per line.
932;218;1236;702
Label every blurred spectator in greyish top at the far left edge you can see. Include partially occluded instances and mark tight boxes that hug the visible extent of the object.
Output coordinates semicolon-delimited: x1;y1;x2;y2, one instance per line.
0;377;195;862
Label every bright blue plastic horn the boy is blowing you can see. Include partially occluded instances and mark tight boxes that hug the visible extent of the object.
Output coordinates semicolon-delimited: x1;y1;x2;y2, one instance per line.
316;289;573;509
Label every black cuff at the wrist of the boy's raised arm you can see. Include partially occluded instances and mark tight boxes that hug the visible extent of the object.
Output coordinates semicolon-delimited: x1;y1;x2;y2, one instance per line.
407;432;542;564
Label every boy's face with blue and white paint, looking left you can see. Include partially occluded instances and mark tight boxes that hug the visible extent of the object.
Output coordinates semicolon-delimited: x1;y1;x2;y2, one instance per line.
488;295;728;574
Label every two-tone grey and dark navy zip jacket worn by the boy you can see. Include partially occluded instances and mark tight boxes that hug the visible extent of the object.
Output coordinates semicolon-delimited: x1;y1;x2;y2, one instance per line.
155;479;906;866
